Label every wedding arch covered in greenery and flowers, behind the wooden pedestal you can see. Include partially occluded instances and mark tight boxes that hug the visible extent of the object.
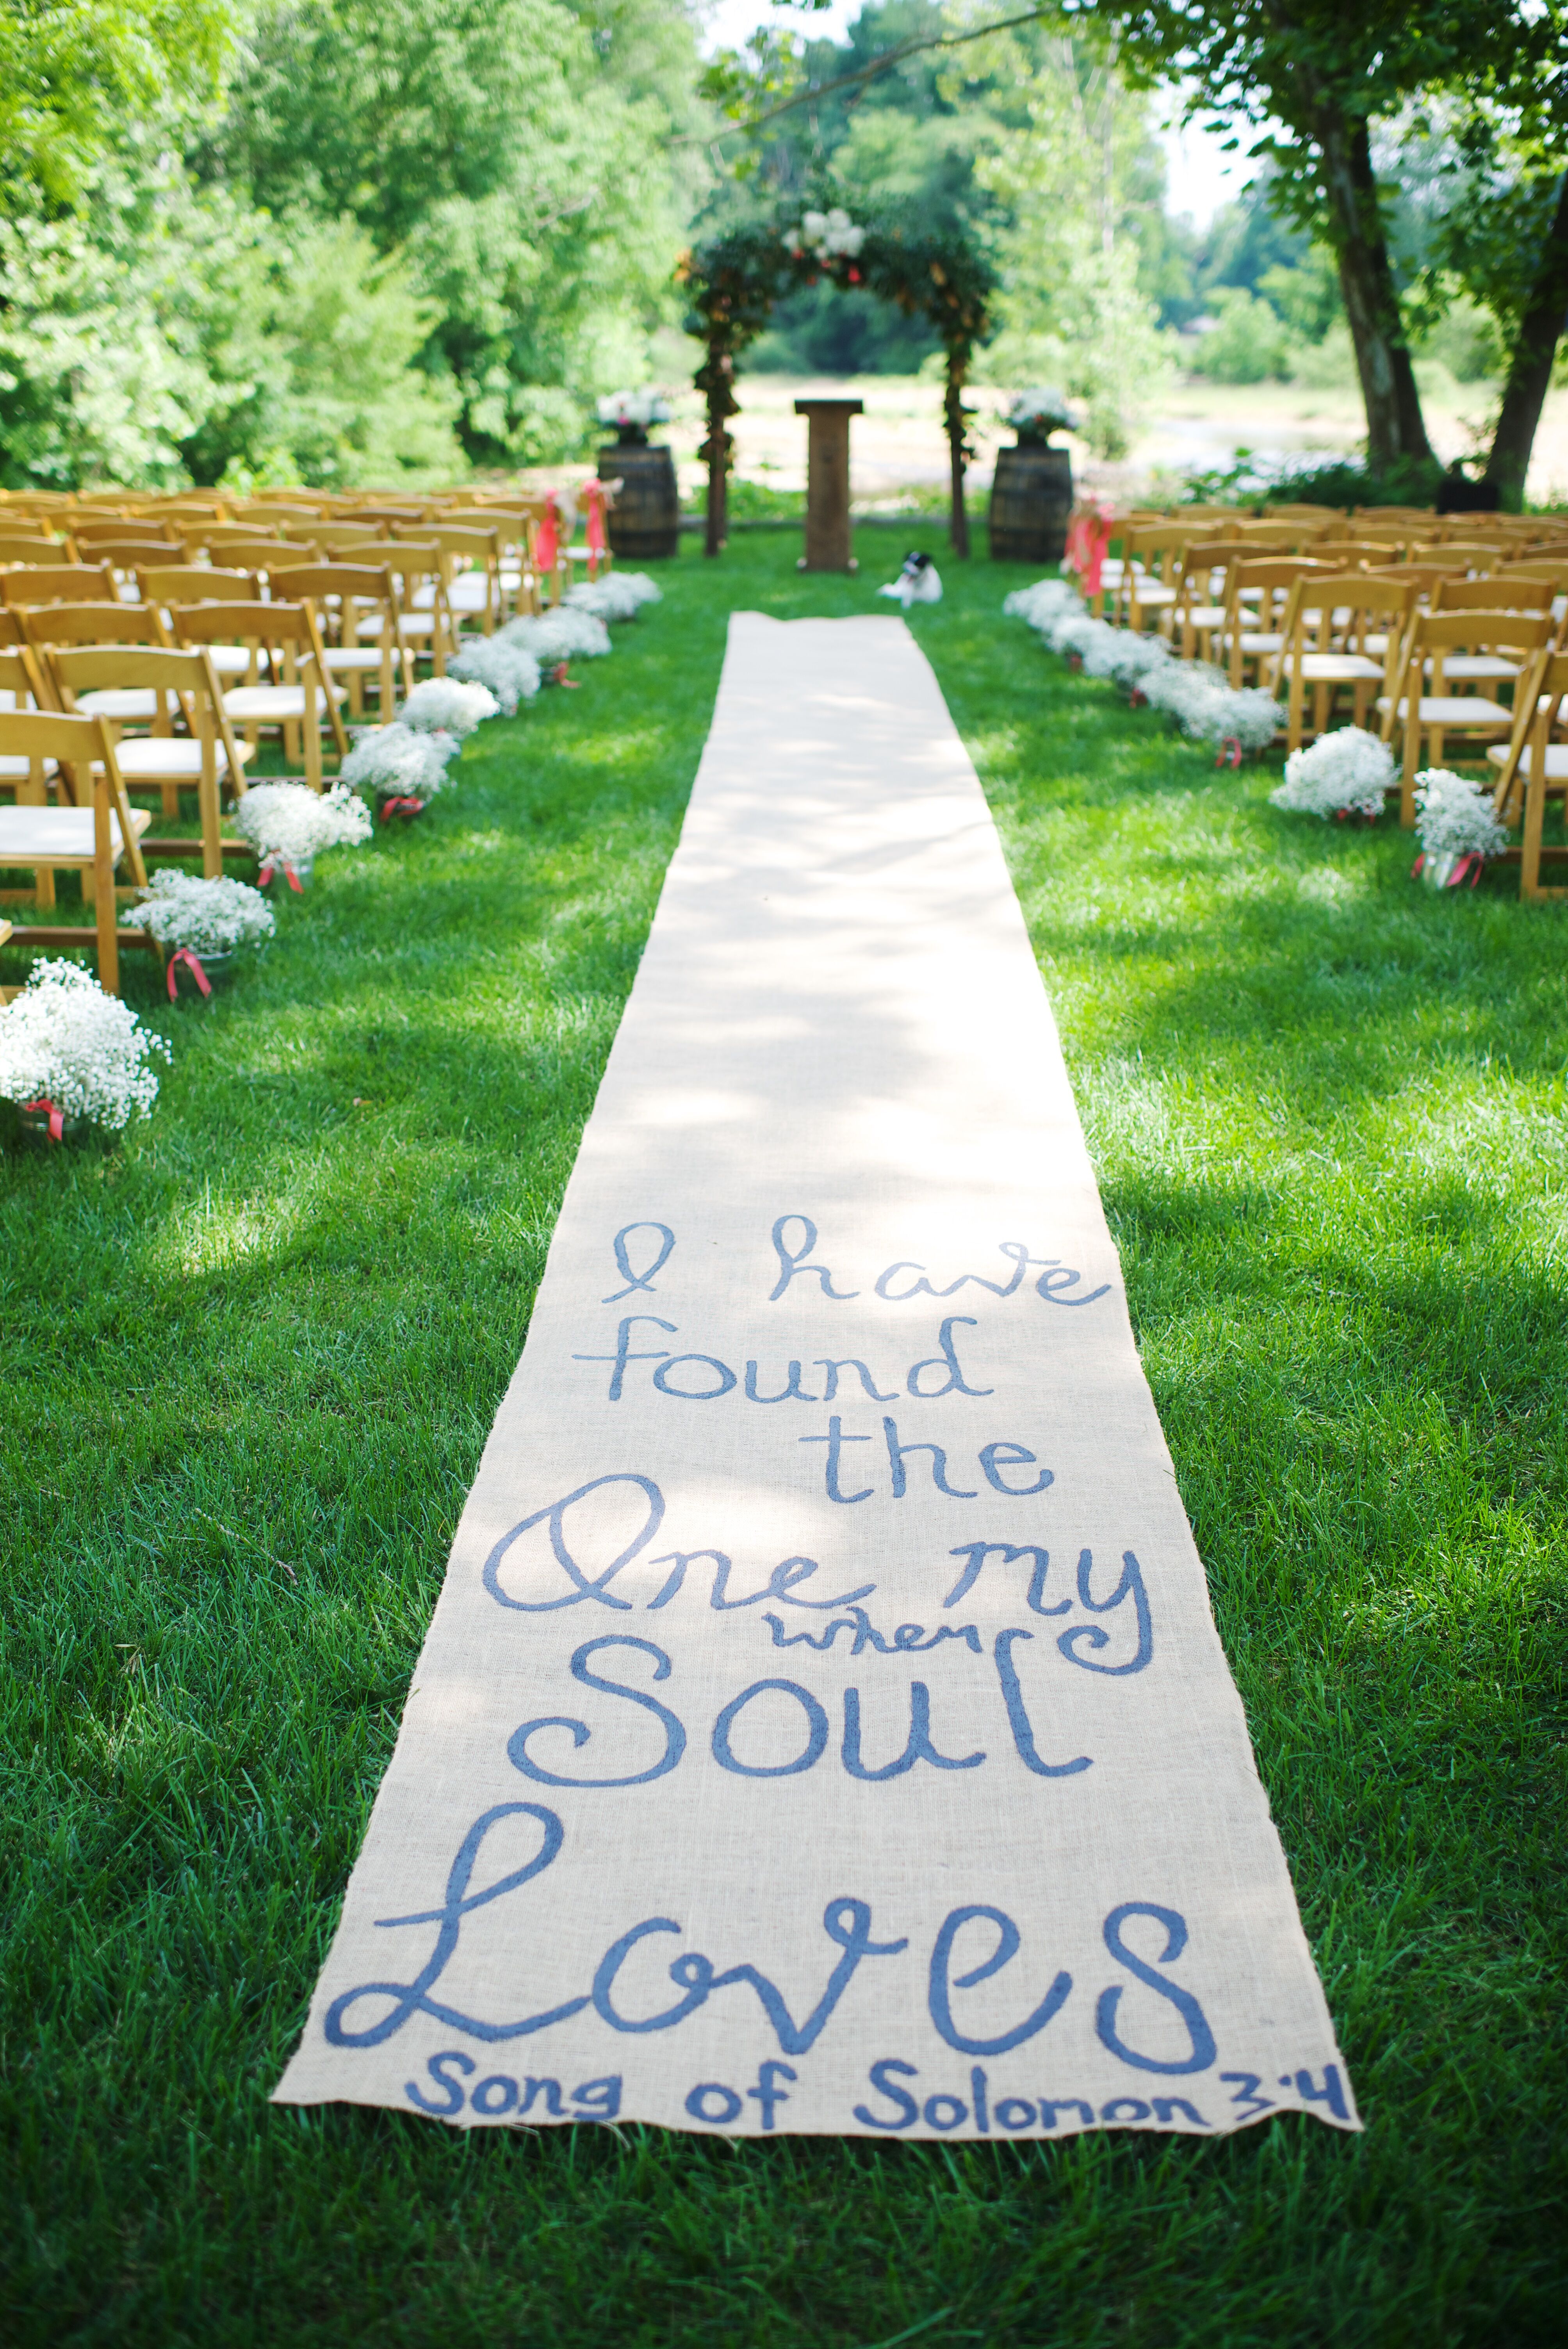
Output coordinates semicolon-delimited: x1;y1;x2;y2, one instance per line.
676;209;995;554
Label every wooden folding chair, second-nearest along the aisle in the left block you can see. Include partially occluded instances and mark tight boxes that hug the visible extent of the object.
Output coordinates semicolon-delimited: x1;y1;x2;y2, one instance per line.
49;643;249;881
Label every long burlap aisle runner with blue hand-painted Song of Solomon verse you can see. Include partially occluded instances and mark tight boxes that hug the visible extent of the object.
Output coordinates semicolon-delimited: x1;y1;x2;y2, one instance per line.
277;613;1357;2138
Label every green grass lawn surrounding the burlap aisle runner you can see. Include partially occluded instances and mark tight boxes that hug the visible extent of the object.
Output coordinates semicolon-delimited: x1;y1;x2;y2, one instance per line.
0;526;1568;2349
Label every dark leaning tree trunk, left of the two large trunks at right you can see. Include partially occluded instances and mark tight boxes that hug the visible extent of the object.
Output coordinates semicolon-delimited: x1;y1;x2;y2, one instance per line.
1315;103;1432;467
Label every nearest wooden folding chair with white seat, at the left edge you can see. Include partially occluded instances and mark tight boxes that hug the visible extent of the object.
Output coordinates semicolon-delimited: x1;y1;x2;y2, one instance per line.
0;709;162;996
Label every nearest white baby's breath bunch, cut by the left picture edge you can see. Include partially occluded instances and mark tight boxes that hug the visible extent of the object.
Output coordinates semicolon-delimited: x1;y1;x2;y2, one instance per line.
0;961;171;1142
